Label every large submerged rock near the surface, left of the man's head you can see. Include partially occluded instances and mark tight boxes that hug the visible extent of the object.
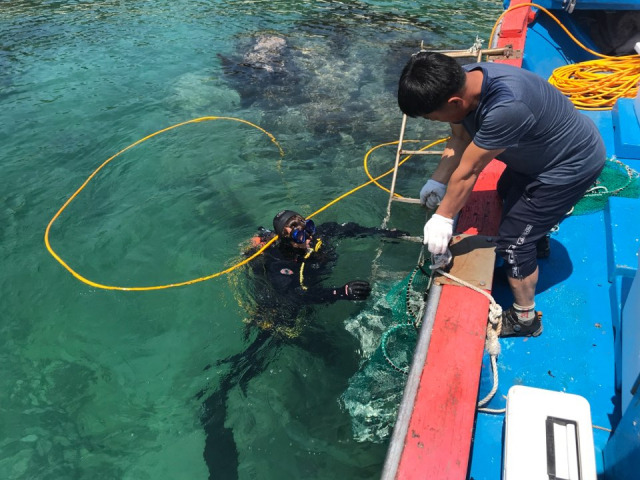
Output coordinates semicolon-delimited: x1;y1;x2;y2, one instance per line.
219;29;408;144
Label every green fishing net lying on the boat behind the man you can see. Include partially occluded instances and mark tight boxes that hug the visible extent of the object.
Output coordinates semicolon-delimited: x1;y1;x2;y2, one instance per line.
571;157;640;215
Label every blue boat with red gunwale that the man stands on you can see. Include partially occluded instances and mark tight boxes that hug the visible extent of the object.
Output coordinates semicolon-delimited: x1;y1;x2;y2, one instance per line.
382;0;640;480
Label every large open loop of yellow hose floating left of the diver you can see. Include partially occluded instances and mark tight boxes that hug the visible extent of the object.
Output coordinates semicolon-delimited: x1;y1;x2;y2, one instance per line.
44;117;284;292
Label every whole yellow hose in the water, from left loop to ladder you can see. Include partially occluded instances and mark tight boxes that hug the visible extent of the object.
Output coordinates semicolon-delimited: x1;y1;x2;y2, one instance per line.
44;116;447;292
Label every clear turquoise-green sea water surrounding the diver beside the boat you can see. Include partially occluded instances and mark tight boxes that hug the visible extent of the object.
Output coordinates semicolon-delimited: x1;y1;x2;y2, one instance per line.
0;0;502;479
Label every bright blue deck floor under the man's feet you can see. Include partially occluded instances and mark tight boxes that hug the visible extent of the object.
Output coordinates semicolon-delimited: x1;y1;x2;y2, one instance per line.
470;212;619;480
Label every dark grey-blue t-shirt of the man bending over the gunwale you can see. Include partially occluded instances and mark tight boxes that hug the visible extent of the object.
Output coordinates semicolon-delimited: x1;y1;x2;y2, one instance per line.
462;63;606;185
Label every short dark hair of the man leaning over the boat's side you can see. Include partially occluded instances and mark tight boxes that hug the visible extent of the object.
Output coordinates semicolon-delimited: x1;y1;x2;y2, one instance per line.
398;52;466;117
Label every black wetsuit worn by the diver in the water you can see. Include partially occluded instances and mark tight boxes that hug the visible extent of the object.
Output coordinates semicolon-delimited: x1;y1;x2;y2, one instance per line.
199;222;407;480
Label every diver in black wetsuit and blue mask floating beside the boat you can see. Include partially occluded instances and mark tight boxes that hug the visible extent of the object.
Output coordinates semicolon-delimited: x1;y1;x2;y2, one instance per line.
198;210;408;479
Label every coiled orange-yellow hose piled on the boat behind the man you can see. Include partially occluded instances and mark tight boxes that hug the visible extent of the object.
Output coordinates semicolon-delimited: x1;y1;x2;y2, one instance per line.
489;3;640;110
